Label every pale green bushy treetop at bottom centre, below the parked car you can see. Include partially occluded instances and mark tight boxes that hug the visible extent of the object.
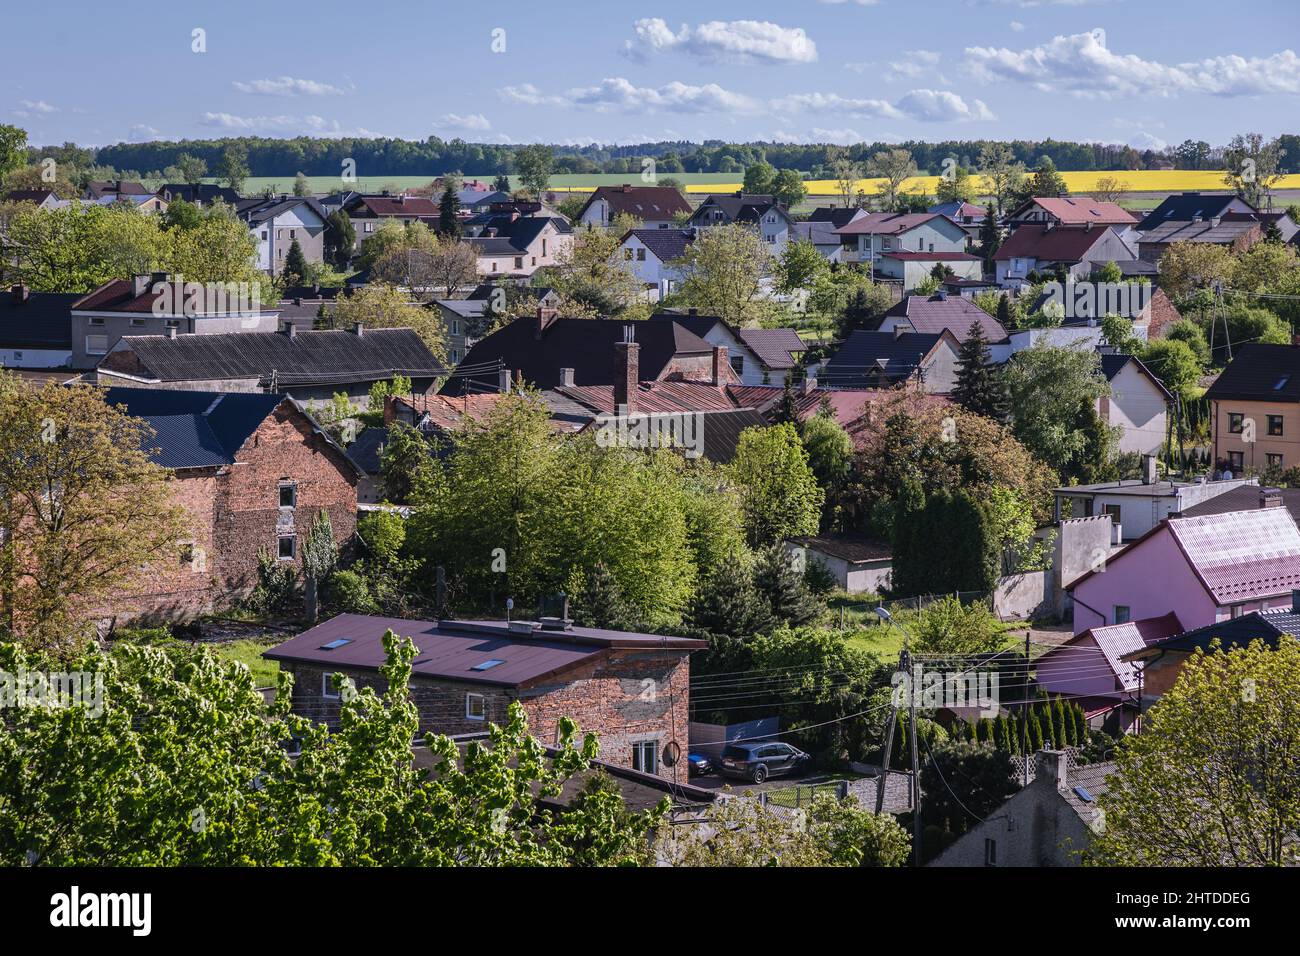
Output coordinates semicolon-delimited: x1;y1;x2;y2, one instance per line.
667;793;911;866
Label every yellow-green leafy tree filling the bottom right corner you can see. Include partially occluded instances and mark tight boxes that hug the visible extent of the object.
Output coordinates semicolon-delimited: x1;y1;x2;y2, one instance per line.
1086;636;1300;866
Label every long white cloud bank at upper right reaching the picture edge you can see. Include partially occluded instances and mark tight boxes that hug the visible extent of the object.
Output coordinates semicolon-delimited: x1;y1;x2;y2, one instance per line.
966;30;1300;99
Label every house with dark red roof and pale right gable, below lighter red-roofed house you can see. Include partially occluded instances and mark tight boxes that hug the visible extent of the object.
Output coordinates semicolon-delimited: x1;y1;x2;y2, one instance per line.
993;222;1138;289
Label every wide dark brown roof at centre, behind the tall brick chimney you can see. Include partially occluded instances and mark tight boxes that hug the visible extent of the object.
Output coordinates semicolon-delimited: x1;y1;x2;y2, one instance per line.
442;316;712;395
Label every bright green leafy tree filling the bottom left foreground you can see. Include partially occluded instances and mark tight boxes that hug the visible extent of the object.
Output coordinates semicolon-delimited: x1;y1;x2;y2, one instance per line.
0;631;667;866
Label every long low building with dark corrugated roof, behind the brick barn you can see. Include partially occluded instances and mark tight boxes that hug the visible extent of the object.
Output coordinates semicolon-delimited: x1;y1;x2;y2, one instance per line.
87;323;446;410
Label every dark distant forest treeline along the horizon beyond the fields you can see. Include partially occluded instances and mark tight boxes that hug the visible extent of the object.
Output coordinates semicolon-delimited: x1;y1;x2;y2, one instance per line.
29;134;1300;178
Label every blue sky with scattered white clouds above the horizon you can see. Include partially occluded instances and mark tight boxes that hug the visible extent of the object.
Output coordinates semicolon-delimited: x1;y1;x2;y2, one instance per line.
0;0;1300;148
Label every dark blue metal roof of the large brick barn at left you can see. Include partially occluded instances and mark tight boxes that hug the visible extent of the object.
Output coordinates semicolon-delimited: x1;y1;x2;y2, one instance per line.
104;388;287;468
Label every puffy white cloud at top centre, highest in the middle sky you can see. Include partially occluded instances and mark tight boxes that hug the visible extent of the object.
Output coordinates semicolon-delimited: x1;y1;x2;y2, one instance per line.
621;17;816;64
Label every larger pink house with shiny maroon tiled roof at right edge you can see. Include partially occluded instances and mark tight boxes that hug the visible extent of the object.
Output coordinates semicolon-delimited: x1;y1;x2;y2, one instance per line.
1066;507;1300;635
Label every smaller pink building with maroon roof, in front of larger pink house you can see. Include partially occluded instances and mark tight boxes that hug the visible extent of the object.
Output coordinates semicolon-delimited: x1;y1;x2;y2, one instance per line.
1035;611;1184;730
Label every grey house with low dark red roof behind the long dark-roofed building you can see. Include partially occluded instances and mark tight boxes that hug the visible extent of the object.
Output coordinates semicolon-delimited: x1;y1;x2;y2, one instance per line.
69;272;280;368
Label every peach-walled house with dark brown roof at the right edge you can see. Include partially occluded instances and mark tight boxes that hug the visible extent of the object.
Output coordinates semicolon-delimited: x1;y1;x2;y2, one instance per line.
1205;339;1300;475
